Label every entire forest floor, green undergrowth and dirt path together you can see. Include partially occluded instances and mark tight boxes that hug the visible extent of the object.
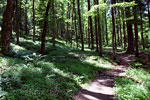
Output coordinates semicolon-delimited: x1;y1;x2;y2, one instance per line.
0;38;150;100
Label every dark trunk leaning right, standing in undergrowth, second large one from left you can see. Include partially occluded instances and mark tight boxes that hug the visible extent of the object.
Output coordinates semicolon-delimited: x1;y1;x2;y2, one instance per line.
41;0;50;55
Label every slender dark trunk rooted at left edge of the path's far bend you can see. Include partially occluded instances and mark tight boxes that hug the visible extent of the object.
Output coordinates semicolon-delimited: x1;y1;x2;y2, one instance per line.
111;0;116;60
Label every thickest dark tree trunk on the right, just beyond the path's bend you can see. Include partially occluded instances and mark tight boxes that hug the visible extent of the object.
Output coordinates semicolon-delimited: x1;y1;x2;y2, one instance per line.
126;4;134;54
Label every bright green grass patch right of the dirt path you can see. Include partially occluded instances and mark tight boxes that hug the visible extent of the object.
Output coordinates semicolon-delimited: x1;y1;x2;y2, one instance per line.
115;59;150;100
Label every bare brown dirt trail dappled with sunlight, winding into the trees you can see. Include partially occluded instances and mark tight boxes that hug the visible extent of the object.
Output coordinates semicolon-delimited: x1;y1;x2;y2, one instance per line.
73;53;132;100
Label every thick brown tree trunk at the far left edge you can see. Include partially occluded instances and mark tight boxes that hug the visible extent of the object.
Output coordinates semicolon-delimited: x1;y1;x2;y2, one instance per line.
0;0;16;54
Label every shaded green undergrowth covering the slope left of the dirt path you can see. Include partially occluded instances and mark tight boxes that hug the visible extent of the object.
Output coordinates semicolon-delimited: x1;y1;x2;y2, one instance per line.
0;39;114;100
